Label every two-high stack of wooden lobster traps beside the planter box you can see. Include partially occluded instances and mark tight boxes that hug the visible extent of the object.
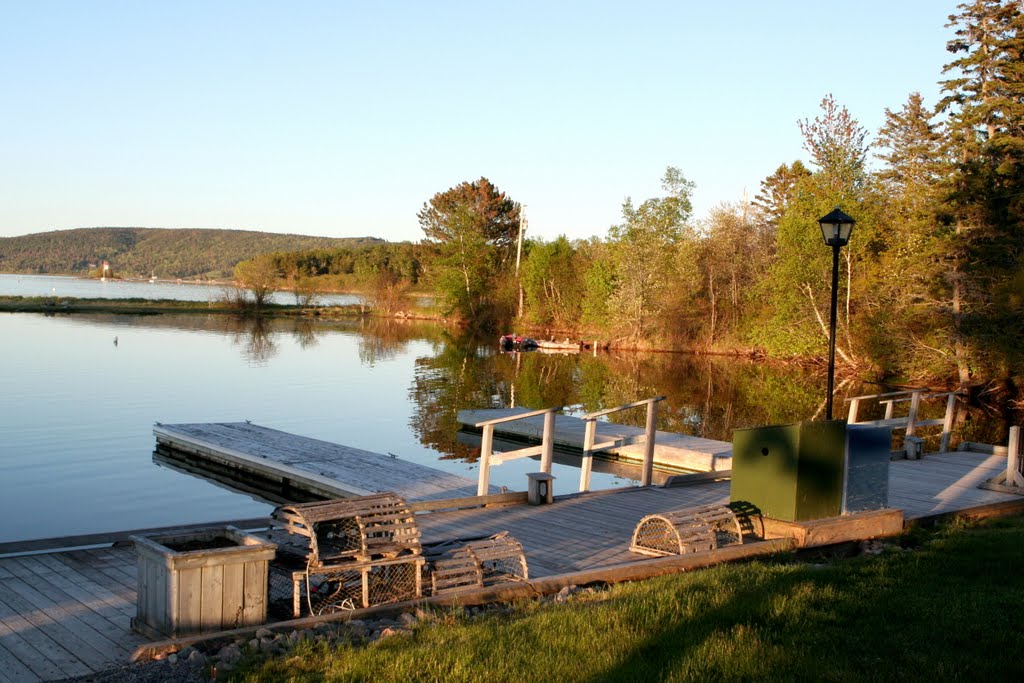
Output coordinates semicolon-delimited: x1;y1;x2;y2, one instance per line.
271;494;426;616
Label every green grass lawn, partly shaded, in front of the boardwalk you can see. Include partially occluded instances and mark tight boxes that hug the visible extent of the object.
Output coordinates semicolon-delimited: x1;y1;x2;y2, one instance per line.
232;518;1024;683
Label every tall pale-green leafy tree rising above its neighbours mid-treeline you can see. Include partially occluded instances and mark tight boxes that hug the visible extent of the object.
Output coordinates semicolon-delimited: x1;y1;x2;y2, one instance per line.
609;166;693;339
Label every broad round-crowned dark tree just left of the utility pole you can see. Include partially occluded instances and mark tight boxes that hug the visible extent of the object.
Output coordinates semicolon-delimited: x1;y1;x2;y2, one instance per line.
417;177;520;325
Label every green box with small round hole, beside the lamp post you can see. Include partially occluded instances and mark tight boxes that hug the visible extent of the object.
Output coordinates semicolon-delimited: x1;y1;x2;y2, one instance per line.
731;420;846;521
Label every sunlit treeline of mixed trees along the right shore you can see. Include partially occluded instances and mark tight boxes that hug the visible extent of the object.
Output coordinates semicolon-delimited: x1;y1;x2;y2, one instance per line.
309;0;1024;390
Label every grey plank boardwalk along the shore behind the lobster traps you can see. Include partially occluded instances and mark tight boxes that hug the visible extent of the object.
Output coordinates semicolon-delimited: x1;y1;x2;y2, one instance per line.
0;453;1024;681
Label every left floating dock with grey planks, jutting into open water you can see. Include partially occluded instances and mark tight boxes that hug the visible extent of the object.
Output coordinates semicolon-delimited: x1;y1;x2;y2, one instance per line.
153;422;487;501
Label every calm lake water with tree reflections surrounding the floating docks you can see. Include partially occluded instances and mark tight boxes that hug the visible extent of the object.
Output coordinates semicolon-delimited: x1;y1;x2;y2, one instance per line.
0;275;1006;542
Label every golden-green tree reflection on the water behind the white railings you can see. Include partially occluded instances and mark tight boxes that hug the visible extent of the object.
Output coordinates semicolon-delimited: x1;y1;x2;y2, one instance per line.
410;336;839;461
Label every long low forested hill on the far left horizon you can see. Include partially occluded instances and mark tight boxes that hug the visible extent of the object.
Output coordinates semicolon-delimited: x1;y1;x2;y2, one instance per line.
0;227;385;279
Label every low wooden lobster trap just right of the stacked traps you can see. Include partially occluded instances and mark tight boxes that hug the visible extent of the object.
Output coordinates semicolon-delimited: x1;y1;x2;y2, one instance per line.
430;531;529;595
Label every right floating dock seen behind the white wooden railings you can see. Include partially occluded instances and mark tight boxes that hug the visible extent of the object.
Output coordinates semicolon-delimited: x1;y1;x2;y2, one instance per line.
459;408;732;472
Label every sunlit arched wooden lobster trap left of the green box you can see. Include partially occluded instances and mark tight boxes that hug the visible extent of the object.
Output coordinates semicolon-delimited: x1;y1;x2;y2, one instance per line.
630;505;743;557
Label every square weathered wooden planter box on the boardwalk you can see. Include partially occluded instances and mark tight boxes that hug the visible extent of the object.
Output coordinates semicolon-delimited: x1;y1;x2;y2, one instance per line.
132;526;276;638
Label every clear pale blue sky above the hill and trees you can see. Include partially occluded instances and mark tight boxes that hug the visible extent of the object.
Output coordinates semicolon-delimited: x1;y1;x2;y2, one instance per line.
0;0;955;241
